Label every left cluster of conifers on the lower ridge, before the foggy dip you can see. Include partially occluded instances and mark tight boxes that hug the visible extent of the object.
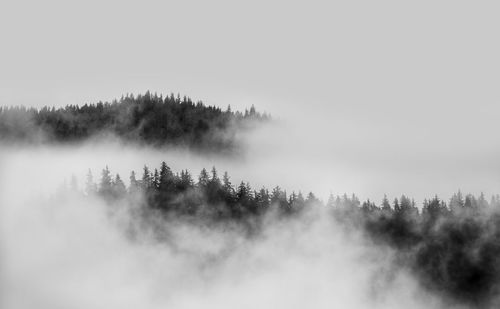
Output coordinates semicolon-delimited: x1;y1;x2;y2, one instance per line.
84;162;320;220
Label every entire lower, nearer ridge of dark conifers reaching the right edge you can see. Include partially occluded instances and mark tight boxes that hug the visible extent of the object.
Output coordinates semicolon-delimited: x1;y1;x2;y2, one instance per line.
65;162;500;307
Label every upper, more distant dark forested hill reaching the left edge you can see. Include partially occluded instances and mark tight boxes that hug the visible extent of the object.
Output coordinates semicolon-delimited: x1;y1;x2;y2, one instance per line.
0;92;269;150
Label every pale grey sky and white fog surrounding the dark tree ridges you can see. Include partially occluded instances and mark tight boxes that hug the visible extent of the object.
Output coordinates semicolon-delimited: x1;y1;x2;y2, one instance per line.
0;0;500;309
